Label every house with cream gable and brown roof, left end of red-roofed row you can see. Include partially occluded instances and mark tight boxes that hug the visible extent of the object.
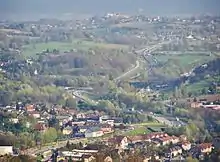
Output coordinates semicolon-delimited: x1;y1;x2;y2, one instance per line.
108;136;129;149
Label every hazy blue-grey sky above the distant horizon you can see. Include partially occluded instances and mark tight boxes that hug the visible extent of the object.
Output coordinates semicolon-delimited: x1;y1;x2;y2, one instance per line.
0;0;220;19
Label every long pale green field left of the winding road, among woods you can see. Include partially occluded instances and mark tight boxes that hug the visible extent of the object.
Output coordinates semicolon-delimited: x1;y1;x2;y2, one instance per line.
22;40;128;57
